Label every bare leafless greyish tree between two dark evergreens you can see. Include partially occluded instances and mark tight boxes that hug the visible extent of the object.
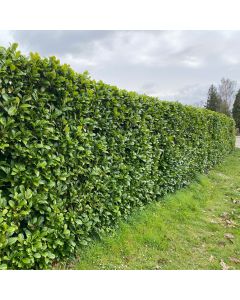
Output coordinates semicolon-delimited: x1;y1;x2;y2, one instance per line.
219;78;236;116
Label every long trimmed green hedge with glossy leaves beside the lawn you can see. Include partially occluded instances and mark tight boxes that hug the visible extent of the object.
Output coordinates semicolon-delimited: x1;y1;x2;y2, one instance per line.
0;44;235;269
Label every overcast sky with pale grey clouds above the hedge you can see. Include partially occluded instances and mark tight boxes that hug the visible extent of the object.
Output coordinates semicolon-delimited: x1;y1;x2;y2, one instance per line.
0;30;240;105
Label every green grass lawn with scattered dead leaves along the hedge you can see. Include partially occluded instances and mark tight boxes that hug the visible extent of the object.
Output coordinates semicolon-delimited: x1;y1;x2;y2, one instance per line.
55;150;240;270
